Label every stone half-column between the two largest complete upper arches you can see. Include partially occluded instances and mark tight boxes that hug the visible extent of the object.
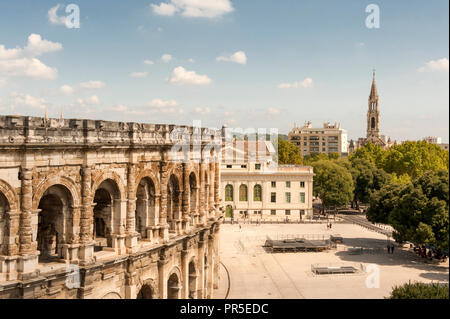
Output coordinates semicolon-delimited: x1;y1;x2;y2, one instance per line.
78;166;94;265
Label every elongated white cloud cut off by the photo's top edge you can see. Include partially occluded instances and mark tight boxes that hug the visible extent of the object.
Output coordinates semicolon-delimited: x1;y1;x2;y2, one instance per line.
151;0;234;18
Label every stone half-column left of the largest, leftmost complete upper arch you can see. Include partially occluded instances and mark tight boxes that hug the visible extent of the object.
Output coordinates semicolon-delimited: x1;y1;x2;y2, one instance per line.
18;168;39;280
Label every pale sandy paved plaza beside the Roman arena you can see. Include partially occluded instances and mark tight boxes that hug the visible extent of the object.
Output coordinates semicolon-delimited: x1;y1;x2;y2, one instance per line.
216;223;449;299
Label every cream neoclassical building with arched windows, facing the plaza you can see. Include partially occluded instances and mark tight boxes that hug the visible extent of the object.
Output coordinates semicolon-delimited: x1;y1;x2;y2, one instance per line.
221;141;314;220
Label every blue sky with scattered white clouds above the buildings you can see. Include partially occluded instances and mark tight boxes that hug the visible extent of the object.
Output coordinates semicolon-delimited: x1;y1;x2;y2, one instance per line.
0;0;449;142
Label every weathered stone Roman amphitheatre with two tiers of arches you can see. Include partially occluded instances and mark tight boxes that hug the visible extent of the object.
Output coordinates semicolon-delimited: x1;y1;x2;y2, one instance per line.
0;116;222;298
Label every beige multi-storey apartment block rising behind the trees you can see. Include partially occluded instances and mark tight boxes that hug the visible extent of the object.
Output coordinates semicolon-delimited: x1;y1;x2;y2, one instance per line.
288;122;348;156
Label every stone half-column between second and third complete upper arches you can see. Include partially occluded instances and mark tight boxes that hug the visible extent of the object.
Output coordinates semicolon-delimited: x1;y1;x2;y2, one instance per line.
126;164;139;253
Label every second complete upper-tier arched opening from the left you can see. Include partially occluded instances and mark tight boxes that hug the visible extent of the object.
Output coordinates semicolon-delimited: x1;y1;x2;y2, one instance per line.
94;179;121;251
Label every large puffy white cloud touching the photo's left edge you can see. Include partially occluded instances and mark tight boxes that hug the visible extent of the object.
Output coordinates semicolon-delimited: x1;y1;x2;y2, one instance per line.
0;34;62;79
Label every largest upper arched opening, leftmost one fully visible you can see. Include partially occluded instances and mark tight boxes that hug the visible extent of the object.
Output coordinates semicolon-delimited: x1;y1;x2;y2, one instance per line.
36;185;73;262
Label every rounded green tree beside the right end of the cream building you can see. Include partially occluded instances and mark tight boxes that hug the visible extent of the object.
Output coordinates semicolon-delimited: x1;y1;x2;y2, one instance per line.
313;160;353;211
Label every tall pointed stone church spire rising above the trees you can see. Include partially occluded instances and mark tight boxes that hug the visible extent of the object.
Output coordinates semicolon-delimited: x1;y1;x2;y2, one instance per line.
349;71;396;153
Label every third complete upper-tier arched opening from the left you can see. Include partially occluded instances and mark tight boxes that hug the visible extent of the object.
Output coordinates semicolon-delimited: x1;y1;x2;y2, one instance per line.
135;177;157;238
